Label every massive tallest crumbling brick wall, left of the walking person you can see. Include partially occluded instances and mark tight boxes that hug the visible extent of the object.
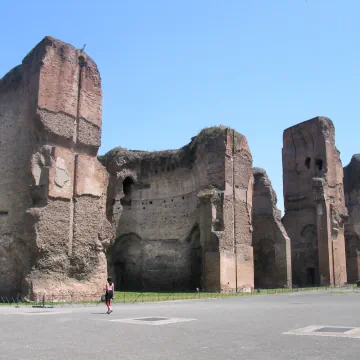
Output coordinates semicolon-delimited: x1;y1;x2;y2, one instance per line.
0;37;110;296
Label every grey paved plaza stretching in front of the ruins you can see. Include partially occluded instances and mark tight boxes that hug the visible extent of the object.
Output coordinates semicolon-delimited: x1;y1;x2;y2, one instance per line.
0;291;360;360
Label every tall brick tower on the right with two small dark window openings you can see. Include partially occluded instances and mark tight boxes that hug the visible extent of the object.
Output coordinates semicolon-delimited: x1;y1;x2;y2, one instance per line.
283;117;347;285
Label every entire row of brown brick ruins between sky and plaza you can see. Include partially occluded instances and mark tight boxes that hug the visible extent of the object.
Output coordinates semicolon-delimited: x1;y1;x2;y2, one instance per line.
0;37;360;298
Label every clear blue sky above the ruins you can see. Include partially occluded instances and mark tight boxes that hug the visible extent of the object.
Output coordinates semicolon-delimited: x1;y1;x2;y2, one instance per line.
0;0;360;209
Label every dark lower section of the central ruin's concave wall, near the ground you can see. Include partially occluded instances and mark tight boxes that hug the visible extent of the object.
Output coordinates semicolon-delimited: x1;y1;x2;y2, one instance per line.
112;230;202;291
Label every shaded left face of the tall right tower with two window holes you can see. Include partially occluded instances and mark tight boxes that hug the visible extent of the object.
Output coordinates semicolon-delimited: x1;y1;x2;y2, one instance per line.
283;124;327;286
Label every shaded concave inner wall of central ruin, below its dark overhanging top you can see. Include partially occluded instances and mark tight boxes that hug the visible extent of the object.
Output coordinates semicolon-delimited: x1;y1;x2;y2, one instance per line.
109;168;202;290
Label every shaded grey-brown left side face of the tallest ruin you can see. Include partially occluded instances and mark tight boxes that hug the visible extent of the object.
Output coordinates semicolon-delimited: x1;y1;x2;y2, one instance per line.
0;67;33;295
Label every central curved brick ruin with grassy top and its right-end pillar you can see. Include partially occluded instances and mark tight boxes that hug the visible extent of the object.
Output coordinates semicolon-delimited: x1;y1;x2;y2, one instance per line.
102;127;253;290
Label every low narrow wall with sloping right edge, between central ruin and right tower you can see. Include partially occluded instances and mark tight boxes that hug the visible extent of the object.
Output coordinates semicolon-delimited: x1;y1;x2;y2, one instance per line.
252;168;292;289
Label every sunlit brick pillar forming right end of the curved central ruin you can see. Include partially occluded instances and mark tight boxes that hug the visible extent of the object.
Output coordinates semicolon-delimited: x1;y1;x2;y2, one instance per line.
197;129;254;291
